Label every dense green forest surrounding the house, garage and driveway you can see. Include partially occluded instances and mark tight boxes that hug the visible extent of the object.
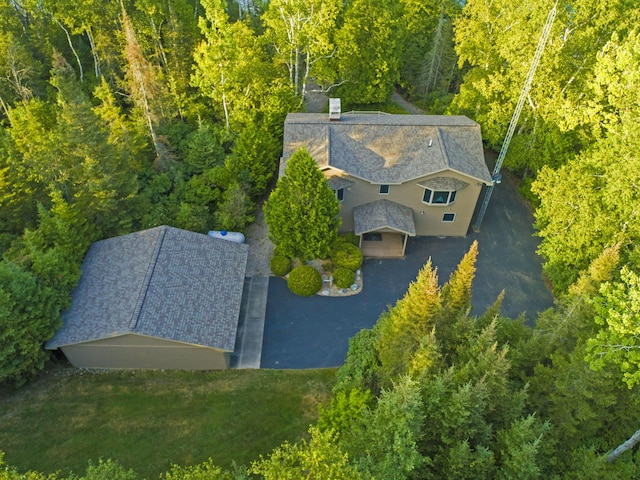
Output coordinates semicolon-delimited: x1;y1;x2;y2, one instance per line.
0;0;640;479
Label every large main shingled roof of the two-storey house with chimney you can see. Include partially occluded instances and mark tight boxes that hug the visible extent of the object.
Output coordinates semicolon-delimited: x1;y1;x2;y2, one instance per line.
283;113;491;185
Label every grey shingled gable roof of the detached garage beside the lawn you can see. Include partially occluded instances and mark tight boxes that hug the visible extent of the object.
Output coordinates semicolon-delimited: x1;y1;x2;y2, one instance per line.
47;226;248;351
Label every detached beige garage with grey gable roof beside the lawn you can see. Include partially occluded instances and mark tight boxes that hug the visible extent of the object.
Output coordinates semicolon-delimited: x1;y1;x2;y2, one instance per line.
46;226;248;370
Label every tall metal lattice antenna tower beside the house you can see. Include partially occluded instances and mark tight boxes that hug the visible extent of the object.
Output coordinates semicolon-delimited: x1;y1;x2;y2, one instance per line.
473;1;558;232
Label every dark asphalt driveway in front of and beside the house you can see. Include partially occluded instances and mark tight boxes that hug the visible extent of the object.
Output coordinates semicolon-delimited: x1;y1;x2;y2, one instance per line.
260;159;553;368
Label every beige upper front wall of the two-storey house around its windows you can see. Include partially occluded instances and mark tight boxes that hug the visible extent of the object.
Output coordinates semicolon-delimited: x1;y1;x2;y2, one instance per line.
325;170;482;237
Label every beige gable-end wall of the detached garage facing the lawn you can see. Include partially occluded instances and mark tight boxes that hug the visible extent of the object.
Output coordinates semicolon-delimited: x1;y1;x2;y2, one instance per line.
61;335;228;370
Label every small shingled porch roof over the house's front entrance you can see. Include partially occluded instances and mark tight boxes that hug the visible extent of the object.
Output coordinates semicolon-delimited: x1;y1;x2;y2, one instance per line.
353;199;416;236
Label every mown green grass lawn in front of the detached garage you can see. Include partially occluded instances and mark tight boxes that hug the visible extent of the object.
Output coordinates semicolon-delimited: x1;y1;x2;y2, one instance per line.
0;367;335;479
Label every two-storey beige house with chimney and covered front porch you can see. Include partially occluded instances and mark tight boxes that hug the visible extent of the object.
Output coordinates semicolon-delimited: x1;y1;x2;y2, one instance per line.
281;108;492;257
